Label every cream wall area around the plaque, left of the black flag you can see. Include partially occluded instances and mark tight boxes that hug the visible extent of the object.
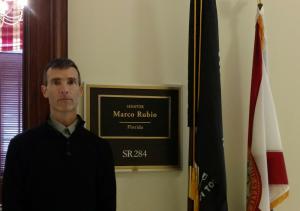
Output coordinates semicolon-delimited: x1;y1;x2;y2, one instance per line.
69;0;188;211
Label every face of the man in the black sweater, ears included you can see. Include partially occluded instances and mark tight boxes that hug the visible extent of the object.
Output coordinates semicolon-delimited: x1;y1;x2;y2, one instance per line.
41;67;83;114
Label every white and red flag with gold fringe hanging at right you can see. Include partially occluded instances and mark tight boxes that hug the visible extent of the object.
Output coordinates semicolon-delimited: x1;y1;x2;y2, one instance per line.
247;5;289;211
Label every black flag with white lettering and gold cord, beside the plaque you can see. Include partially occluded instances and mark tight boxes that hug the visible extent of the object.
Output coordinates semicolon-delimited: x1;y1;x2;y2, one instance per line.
188;0;228;211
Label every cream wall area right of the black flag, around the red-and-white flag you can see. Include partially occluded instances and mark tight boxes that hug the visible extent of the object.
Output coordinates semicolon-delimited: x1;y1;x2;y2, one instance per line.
218;0;300;211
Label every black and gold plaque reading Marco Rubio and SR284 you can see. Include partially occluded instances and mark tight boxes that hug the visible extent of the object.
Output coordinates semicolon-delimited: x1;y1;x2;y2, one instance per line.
86;85;179;169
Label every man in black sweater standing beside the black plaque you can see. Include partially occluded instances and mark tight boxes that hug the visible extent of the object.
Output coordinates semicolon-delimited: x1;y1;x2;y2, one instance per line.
3;59;116;211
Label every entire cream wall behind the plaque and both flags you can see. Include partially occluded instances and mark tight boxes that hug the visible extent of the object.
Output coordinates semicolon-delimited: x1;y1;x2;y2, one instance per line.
69;0;300;211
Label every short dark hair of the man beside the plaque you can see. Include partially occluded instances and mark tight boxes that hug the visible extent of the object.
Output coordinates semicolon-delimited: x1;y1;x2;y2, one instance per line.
42;58;81;85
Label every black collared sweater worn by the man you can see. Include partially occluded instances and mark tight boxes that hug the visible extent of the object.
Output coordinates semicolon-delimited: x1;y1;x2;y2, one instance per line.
3;119;116;211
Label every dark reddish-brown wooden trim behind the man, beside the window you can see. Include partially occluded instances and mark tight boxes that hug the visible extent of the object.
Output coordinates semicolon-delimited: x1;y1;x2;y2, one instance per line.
23;0;68;129
